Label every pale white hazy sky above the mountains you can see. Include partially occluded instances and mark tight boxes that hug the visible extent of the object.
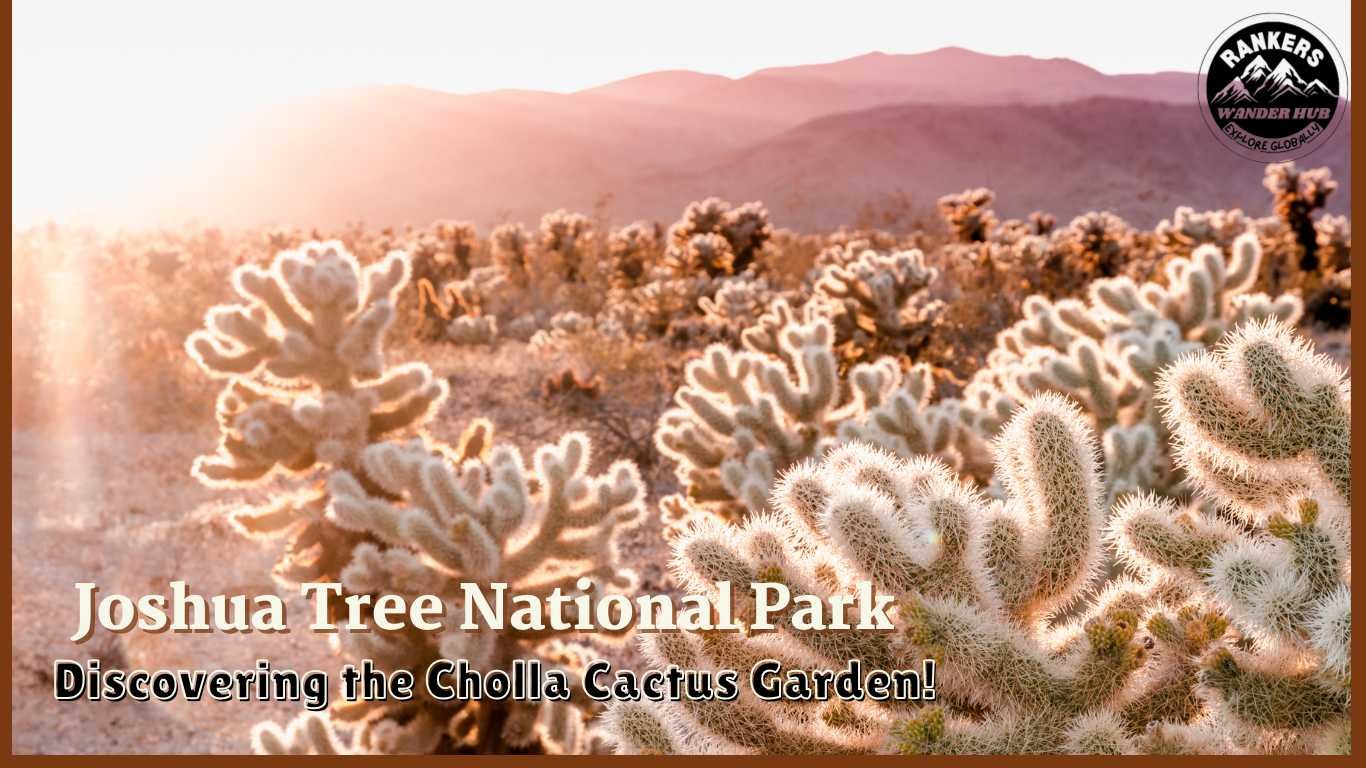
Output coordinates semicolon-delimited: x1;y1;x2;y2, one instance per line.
12;0;1351;224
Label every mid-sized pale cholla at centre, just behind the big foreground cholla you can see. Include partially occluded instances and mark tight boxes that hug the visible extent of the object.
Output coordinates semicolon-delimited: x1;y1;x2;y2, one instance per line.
656;307;952;517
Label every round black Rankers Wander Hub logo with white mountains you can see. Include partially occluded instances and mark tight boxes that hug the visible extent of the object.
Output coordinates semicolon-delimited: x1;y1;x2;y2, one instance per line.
1199;14;1347;163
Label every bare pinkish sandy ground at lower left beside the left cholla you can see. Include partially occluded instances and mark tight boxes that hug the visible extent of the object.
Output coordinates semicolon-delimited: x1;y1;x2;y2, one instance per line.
11;433;335;753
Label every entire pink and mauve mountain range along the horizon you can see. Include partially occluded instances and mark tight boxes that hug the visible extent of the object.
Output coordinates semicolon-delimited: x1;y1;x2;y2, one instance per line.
130;48;1351;230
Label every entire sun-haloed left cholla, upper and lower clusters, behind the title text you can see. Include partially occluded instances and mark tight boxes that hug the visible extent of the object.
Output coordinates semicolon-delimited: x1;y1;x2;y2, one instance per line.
186;242;643;753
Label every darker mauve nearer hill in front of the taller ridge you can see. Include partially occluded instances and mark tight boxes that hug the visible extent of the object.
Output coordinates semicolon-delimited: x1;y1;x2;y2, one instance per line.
639;98;1351;228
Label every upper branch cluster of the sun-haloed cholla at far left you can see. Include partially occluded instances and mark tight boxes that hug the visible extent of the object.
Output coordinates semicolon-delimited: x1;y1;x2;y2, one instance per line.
186;242;445;485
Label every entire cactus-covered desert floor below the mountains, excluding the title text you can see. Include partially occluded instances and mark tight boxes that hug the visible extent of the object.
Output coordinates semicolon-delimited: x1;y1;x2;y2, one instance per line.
11;158;1351;753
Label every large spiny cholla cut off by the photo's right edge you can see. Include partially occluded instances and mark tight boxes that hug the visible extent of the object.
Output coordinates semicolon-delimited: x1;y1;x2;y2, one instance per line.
1111;323;1351;752
